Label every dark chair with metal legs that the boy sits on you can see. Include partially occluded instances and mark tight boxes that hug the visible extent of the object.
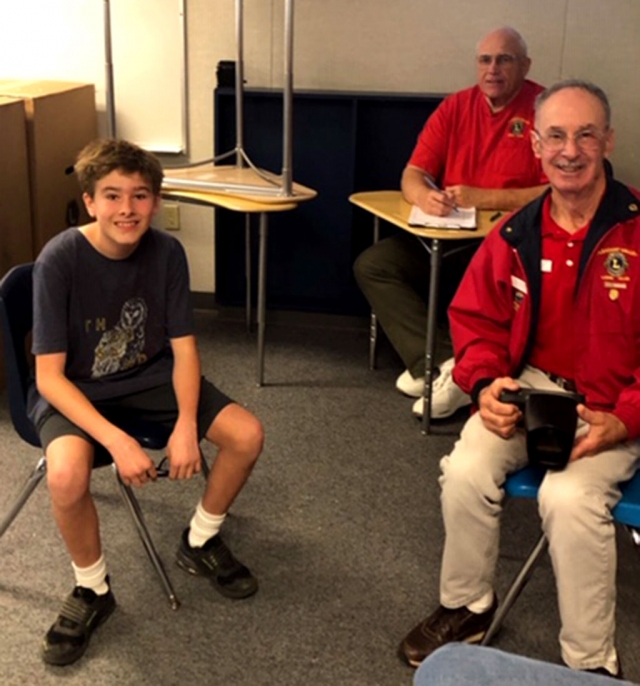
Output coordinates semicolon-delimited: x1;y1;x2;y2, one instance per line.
0;264;192;610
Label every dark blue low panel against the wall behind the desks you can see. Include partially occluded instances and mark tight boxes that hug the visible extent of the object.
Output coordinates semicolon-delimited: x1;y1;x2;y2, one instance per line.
215;88;441;314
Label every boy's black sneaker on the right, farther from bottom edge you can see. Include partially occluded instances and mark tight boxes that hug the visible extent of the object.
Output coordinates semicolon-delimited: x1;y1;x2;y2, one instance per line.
176;529;258;600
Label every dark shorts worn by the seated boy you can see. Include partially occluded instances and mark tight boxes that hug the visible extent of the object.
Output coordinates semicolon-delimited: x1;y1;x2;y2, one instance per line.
36;378;233;450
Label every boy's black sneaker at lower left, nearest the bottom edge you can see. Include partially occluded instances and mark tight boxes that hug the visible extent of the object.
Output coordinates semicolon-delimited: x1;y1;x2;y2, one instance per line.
42;586;116;666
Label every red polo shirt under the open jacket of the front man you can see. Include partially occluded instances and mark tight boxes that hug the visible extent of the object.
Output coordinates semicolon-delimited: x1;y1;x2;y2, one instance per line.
529;196;589;379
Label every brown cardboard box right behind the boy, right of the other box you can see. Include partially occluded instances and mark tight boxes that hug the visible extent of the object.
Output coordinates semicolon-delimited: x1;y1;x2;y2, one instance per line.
0;80;98;257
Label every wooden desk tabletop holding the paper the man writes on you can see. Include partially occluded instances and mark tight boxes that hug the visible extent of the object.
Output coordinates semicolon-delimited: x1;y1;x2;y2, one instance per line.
349;191;507;241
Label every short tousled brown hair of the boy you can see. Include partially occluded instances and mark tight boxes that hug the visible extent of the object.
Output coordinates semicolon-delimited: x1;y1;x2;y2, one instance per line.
74;138;164;198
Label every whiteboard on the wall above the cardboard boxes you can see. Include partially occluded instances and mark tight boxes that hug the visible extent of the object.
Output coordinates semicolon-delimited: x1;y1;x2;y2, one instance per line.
0;0;187;153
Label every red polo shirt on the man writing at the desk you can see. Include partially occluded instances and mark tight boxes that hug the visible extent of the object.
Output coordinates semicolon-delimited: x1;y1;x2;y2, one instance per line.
409;81;547;188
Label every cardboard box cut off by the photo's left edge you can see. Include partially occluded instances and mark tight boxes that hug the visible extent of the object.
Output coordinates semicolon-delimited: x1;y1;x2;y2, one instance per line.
0;97;33;388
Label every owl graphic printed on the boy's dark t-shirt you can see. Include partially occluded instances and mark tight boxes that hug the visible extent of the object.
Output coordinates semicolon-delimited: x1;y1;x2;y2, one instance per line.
91;298;147;379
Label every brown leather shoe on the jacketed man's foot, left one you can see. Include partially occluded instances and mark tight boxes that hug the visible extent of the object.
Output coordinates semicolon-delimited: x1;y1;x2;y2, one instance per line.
398;596;498;667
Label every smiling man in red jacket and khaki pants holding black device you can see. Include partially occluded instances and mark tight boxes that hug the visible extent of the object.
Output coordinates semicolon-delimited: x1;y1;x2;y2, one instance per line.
400;80;640;676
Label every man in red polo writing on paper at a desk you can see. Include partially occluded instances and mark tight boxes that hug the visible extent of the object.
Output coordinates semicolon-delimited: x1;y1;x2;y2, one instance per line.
354;28;546;418
